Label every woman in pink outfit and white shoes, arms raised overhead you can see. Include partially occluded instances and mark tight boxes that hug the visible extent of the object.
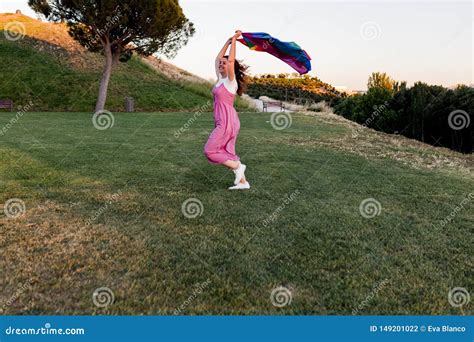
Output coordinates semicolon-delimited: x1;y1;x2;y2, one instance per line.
204;31;250;190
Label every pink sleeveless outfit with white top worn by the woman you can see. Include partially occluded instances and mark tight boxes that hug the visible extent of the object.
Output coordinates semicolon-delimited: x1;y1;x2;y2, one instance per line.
204;78;240;164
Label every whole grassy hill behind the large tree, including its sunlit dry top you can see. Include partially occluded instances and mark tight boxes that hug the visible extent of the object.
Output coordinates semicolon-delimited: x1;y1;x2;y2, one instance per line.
0;14;252;111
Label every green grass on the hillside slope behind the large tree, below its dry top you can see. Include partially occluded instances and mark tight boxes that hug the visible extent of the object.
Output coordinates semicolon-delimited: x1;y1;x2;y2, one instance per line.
0;35;225;111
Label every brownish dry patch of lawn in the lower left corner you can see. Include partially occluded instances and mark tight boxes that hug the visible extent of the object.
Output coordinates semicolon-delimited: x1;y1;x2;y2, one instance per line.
0;201;156;315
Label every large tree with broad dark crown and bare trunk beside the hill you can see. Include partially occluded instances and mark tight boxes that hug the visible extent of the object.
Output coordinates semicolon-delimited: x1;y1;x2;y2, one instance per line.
28;0;194;112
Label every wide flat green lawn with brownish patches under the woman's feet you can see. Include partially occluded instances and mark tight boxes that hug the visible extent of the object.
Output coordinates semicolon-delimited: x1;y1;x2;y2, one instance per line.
0;113;474;315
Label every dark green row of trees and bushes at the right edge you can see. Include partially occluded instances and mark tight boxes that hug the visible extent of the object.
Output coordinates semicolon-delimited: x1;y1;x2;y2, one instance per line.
332;73;474;153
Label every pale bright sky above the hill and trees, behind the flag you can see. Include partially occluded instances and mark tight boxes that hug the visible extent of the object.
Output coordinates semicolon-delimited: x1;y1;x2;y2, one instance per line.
0;0;474;90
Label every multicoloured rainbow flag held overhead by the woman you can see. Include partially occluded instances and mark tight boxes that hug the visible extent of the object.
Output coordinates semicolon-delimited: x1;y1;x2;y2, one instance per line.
238;32;311;75
